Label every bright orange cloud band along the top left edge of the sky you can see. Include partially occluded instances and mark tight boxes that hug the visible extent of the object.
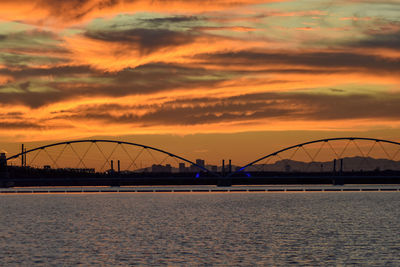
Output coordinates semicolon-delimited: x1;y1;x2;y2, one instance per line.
0;0;281;27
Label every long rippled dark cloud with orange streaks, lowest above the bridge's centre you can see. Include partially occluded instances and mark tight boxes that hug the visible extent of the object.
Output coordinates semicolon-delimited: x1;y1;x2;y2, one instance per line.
49;94;289;126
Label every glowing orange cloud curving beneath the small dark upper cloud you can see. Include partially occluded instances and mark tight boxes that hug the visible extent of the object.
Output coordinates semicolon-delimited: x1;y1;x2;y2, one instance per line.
66;29;264;71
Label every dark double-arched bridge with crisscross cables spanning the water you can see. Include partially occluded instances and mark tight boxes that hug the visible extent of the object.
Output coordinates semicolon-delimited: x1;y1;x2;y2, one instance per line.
2;137;400;185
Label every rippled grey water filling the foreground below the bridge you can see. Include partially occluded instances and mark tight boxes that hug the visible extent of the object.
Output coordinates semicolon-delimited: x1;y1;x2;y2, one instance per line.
0;192;400;266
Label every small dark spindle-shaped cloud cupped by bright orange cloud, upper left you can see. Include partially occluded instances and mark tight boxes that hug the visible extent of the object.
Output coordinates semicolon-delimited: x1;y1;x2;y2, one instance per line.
85;28;197;54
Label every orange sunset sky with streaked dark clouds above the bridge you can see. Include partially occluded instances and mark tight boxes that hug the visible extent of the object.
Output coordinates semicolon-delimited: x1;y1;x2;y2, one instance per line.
0;0;400;164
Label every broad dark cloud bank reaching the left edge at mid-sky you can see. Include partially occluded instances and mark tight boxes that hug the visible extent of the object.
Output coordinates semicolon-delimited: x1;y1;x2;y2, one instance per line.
0;64;229;108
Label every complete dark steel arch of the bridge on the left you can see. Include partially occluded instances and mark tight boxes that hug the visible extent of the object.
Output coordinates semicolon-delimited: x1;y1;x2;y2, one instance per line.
7;139;220;177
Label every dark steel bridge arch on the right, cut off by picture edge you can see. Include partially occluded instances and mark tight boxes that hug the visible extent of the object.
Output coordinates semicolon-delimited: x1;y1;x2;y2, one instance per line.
233;137;400;176
